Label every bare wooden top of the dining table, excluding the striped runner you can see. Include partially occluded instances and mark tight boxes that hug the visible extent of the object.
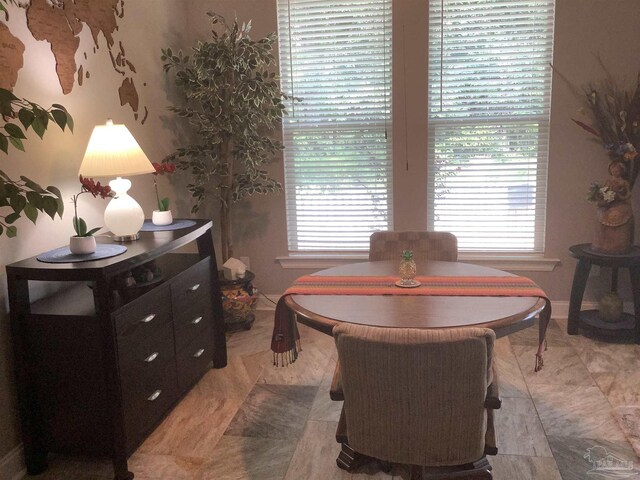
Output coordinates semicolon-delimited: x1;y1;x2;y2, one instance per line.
284;261;547;337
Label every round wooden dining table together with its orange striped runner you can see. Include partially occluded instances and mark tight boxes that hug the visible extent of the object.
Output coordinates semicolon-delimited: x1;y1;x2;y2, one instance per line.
272;261;551;370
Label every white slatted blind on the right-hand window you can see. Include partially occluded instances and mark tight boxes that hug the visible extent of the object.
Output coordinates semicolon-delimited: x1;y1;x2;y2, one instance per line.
428;0;554;252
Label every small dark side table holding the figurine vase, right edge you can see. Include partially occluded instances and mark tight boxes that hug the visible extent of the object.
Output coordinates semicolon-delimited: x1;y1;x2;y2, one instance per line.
567;243;640;343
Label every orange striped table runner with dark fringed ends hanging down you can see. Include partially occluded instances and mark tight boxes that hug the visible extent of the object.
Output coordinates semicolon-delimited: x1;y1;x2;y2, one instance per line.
271;275;551;372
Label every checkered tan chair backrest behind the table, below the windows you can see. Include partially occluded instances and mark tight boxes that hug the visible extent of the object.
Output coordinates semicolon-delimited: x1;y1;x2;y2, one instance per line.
369;232;458;262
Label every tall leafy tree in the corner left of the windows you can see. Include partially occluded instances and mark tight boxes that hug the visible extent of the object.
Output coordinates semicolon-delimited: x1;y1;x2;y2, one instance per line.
161;13;294;329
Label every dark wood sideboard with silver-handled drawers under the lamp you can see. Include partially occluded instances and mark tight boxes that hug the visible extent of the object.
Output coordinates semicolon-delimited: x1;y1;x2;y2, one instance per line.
6;220;227;480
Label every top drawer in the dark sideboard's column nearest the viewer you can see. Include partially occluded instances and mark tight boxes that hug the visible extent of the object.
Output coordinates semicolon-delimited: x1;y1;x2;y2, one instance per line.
115;285;171;350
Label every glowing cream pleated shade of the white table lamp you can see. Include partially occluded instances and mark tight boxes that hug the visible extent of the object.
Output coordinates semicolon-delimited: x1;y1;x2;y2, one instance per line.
78;120;155;177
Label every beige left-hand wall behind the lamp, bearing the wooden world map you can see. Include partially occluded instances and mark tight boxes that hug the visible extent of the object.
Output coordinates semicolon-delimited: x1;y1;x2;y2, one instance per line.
0;0;188;464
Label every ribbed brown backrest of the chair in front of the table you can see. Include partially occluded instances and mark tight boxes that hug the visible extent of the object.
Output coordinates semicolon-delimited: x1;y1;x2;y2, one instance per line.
333;324;495;466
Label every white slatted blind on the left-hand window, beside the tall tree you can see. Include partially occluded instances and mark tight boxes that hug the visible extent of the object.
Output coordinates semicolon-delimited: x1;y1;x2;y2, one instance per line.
278;0;392;251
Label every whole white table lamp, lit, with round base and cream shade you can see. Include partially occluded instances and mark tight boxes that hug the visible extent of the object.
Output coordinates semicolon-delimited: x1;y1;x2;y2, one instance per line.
78;119;155;242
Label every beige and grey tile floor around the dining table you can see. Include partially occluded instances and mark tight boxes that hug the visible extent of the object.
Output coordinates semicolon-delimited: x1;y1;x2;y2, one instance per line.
34;311;640;480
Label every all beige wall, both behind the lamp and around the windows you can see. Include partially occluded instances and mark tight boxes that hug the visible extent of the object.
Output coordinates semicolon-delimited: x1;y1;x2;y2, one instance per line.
0;0;640;461
